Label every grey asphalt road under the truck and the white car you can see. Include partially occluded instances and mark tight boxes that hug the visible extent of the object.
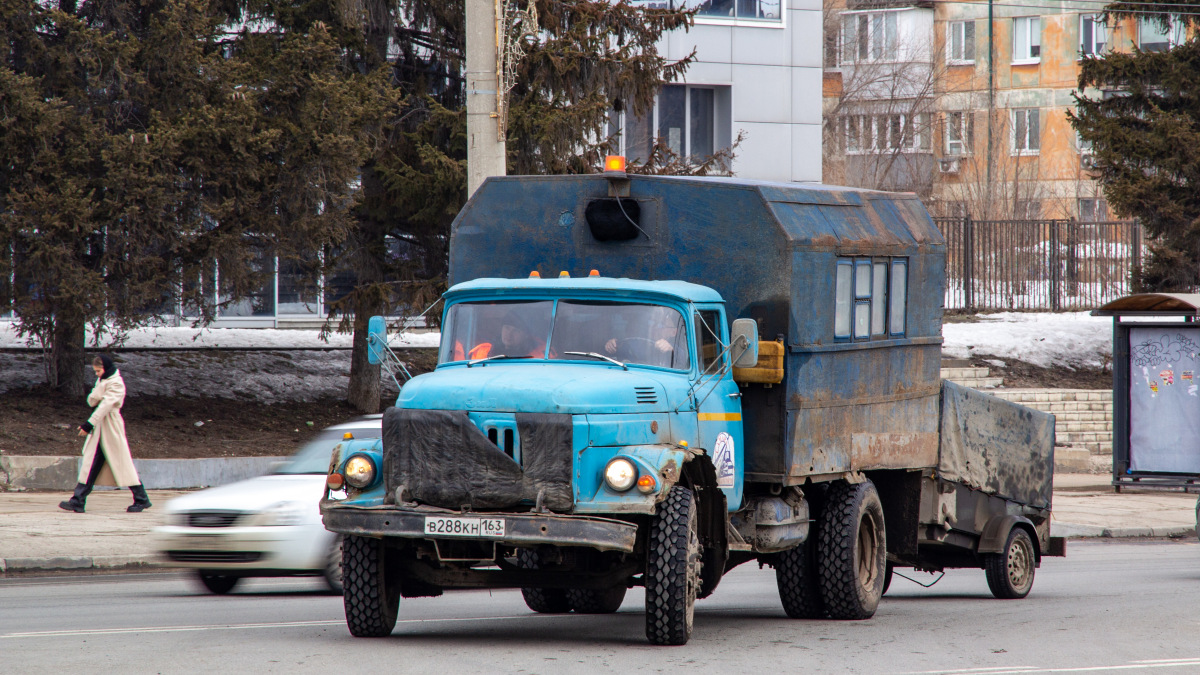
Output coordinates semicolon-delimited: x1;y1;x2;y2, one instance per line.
7;540;1200;675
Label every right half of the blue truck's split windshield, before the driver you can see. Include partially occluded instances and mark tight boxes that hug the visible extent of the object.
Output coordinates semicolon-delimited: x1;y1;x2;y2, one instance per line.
550;300;691;370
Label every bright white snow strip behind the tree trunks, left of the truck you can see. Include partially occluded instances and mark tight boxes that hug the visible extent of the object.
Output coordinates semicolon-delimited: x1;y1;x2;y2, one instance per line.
0;322;440;350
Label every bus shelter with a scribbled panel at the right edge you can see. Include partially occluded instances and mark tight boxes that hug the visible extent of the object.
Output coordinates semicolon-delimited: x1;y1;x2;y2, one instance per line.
1092;293;1200;491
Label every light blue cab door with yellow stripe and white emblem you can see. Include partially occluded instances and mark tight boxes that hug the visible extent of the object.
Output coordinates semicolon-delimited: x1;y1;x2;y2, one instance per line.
692;305;745;510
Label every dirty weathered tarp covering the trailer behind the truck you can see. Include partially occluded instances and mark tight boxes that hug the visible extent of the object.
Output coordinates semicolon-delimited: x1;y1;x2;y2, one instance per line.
937;381;1054;508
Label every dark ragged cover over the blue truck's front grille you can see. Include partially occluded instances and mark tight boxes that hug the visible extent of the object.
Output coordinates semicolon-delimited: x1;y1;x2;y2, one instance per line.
383;407;574;510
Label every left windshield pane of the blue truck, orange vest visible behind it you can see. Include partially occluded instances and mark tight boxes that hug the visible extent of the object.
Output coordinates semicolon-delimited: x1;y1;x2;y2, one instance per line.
438;300;554;363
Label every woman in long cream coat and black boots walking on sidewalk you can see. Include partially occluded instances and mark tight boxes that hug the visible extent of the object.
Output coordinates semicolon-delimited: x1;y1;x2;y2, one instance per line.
59;354;150;513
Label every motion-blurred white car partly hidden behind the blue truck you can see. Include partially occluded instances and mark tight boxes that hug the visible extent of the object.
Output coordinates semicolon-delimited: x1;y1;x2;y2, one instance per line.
154;414;383;593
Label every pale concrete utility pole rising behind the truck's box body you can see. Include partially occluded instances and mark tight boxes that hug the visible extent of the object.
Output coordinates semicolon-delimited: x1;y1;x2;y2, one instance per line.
466;0;506;197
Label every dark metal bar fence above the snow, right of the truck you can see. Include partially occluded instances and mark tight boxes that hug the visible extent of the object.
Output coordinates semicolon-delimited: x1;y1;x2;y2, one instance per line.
934;217;1142;311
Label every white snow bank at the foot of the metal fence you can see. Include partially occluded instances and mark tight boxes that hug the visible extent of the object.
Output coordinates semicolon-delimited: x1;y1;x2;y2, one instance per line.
942;312;1112;369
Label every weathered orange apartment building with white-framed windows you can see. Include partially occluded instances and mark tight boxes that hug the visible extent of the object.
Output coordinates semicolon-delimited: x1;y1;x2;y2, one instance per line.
823;0;1161;216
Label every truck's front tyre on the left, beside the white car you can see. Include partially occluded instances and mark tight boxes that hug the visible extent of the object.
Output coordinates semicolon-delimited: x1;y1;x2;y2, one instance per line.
342;537;400;638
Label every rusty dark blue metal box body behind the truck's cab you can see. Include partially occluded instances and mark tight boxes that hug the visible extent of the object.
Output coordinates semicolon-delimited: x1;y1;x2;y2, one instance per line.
450;175;946;484
